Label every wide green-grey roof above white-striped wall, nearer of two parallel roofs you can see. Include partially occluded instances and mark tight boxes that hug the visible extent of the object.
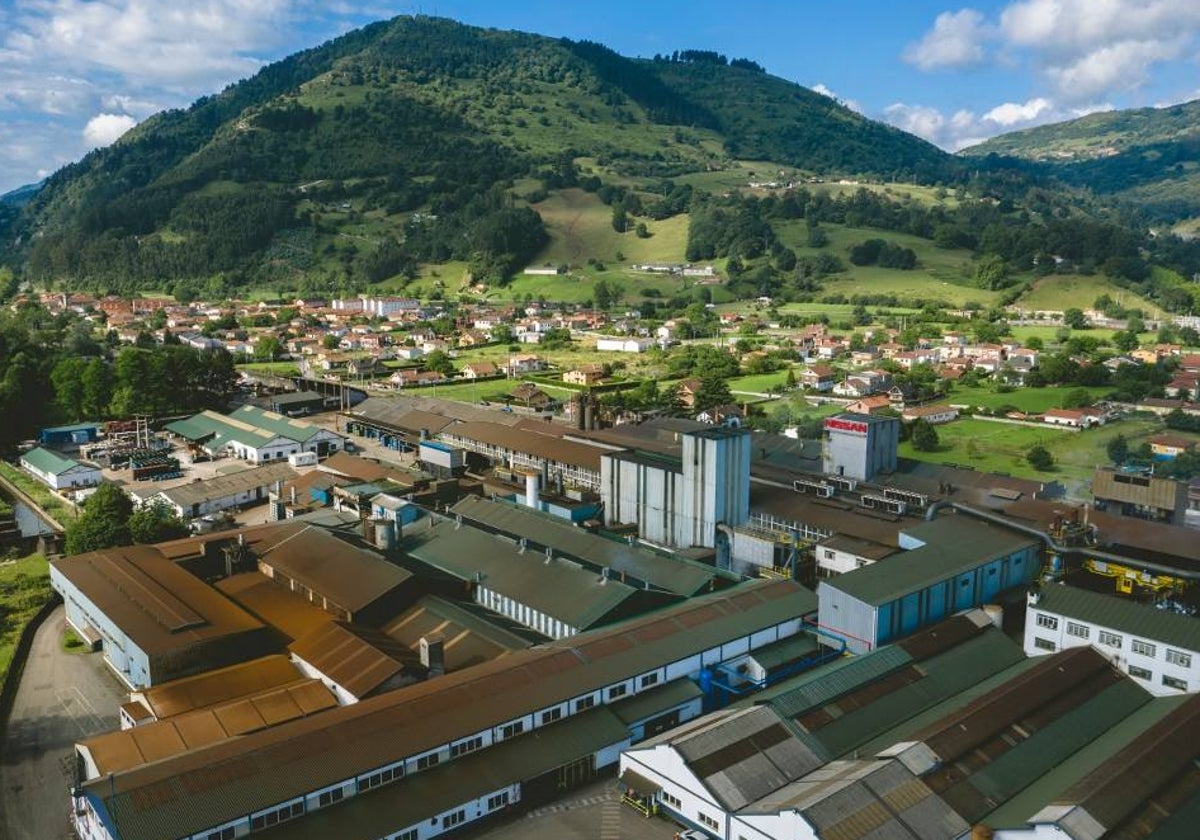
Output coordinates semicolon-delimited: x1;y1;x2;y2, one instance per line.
404;520;638;630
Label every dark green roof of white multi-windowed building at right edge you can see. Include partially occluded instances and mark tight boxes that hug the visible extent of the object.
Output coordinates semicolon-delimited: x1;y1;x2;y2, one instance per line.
1036;584;1200;650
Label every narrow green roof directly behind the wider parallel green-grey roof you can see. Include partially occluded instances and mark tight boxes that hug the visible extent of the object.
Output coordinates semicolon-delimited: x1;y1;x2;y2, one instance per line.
452;496;715;595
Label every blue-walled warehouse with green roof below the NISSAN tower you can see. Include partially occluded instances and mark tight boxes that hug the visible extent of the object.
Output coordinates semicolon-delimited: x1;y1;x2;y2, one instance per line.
817;515;1042;653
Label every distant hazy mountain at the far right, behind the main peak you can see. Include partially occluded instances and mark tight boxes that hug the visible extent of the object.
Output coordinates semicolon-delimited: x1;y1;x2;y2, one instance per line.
961;100;1200;222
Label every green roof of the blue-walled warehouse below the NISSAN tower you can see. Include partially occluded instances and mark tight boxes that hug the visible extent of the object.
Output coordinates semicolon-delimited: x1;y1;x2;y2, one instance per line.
821;515;1037;606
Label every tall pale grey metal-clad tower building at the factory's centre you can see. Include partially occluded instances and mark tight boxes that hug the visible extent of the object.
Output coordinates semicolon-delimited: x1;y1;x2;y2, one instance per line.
600;427;750;548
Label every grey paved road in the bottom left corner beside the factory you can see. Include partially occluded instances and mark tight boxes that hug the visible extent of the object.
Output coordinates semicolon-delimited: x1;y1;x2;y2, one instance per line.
0;606;128;840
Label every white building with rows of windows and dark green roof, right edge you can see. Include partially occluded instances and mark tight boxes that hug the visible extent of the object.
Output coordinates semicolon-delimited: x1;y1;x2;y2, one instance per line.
1025;586;1200;695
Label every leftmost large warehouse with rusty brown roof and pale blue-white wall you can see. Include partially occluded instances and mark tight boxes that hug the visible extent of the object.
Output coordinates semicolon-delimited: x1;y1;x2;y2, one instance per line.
50;546;271;689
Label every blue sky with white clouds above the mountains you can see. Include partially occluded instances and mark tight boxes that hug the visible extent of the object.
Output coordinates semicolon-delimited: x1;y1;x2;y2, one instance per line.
0;0;1200;192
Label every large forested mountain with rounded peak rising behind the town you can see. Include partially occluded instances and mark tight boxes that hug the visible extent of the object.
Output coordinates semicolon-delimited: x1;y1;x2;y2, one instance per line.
5;17;960;290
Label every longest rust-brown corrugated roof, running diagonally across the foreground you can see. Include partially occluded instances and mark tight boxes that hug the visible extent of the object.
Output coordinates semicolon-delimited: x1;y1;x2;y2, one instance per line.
85;581;816;840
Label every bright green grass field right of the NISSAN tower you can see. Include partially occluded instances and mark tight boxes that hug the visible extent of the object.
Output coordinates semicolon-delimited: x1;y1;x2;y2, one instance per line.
900;418;1163;484
